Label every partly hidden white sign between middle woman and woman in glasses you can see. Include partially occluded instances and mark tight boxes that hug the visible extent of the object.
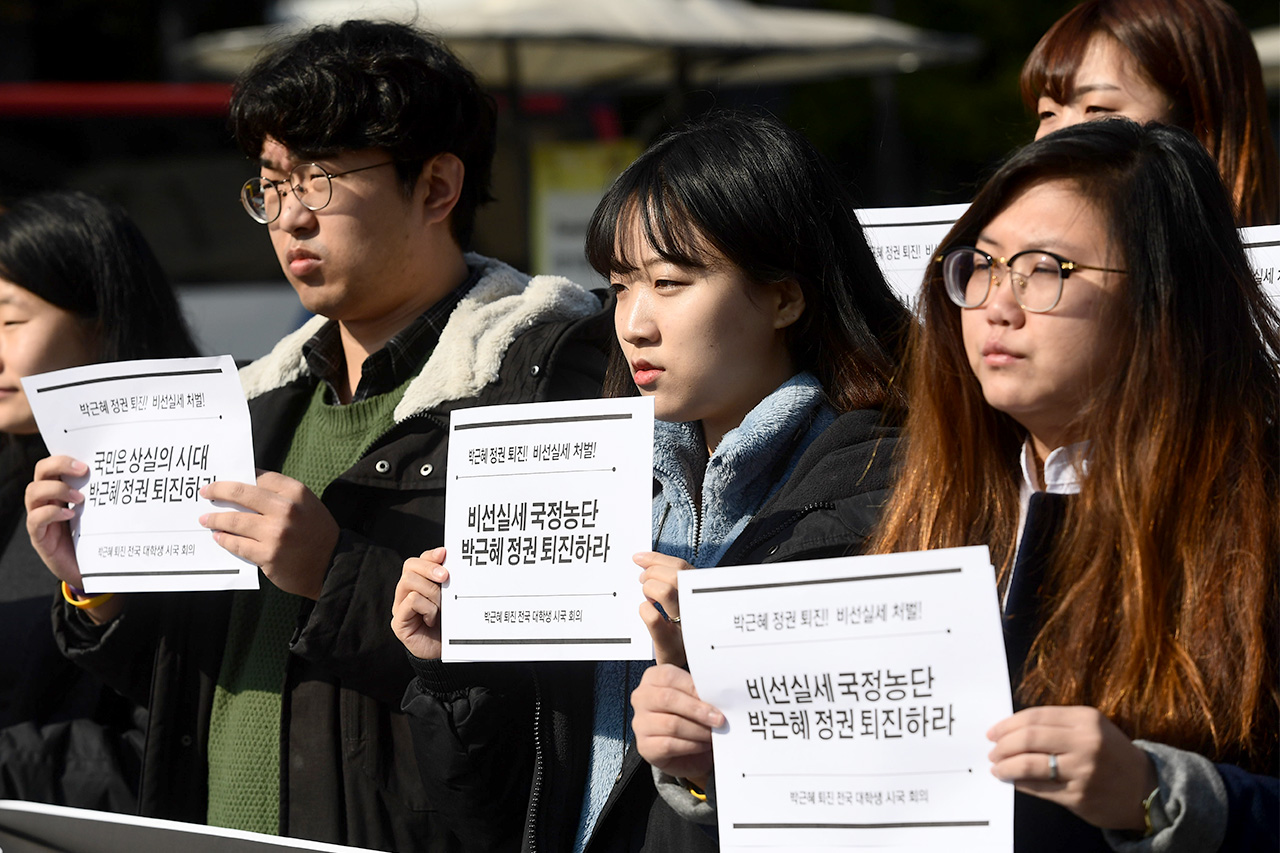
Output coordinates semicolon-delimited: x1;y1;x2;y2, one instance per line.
858;204;969;307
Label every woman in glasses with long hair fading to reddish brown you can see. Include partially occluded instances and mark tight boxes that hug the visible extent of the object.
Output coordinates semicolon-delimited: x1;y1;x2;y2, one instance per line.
873;119;1280;852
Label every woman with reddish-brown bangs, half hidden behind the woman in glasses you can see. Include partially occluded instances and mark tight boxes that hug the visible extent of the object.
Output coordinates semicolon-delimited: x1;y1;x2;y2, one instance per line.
1021;0;1280;225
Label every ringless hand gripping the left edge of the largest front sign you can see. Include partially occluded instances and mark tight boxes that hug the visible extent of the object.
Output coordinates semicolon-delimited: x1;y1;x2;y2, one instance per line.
631;663;724;788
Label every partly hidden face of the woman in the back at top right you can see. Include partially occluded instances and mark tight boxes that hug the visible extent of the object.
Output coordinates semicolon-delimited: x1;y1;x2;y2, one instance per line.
1036;33;1172;140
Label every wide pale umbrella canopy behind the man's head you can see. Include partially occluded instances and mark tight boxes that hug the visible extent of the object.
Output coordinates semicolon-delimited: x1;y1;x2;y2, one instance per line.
180;0;978;91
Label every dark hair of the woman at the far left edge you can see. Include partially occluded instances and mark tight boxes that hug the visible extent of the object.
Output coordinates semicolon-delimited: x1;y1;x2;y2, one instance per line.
0;191;196;361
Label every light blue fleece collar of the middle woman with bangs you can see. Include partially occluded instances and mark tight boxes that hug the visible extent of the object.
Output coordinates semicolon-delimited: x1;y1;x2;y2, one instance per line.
653;373;836;567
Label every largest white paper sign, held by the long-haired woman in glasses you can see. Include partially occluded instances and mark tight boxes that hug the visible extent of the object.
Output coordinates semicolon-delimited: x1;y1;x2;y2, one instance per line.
680;547;1014;853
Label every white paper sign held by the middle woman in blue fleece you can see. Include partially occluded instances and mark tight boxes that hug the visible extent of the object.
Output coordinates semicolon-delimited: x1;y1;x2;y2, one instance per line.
440;397;653;661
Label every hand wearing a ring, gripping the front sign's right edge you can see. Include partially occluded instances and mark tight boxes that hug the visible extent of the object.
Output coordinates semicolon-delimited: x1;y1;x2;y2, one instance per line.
987;706;1157;830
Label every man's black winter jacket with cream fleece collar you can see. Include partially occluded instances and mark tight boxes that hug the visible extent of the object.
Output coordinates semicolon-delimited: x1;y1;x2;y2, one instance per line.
58;256;612;852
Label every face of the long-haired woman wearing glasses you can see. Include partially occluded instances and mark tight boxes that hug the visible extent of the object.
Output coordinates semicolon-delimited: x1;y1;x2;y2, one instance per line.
956;181;1125;459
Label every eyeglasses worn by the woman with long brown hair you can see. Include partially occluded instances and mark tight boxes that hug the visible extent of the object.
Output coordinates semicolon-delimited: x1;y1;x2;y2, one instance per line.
933;246;1126;314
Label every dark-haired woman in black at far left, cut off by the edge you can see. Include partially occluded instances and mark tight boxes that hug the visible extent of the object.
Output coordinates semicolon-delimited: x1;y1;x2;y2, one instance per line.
0;192;196;812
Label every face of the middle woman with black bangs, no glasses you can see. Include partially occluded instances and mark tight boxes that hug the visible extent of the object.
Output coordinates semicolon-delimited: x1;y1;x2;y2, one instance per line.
611;216;804;448
